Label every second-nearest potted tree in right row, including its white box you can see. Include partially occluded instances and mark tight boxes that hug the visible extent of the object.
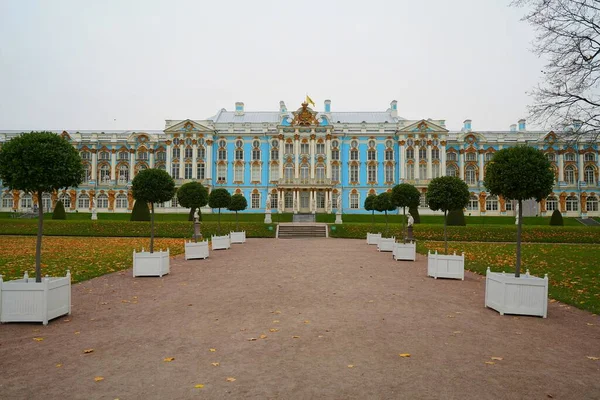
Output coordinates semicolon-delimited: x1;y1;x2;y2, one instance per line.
426;176;470;280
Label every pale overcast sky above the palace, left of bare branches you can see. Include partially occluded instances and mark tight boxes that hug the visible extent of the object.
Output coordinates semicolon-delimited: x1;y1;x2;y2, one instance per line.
0;0;543;130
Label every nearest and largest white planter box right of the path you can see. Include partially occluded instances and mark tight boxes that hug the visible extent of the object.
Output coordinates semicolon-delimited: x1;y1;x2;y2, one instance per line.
485;268;548;318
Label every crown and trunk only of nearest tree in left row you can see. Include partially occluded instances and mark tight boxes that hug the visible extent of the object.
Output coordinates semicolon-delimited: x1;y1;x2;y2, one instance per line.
0;132;84;282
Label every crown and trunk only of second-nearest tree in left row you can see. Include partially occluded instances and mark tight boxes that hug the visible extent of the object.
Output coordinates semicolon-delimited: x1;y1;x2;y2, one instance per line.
131;168;175;253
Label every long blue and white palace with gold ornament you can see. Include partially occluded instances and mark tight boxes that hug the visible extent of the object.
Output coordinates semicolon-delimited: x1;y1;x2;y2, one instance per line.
0;100;600;217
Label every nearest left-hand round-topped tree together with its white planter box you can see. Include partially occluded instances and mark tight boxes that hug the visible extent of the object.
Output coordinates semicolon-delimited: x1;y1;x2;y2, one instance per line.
0;132;84;325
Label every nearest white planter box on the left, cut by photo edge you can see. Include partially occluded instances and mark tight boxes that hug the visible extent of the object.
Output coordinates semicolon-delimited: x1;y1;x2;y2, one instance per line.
0;271;71;325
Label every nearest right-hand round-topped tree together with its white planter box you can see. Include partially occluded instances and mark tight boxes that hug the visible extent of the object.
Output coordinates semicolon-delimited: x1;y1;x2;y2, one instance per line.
484;146;554;318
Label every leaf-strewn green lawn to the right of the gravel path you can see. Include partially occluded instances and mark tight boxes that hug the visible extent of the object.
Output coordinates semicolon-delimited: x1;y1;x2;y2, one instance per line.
417;242;600;314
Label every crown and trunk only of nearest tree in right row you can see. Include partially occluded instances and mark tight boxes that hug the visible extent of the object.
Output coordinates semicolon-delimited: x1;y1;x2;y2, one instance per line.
484;146;554;278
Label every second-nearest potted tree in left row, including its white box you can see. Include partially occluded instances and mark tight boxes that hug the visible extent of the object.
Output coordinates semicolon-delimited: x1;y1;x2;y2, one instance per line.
131;168;175;277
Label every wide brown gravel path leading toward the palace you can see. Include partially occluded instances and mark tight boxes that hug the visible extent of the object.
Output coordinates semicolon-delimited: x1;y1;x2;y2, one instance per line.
0;239;600;400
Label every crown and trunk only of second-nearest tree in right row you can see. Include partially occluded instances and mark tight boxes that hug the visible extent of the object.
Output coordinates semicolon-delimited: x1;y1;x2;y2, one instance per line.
426;176;471;254
